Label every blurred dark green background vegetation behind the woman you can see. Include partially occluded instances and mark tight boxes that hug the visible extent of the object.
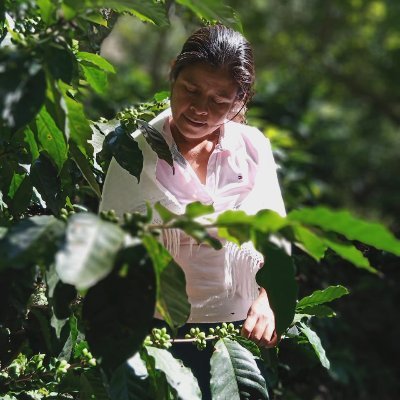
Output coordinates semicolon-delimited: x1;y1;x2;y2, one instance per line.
87;0;400;399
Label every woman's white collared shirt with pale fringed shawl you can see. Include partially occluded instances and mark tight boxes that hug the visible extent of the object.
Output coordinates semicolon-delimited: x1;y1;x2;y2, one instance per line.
100;108;285;323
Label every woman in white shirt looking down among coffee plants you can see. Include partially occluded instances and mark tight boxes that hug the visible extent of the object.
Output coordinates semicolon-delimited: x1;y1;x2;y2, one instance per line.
101;25;285;398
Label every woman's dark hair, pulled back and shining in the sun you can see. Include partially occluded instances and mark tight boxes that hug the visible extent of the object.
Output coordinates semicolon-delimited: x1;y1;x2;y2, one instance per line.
170;24;255;105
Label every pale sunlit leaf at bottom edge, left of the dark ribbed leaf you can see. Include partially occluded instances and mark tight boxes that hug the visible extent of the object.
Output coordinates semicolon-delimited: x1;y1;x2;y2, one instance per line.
145;346;201;400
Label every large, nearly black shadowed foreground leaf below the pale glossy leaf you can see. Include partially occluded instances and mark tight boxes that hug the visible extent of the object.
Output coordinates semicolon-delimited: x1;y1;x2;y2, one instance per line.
82;244;156;374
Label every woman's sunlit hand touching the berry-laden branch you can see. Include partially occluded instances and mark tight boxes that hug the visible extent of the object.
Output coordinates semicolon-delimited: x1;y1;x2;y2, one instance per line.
241;288;278;347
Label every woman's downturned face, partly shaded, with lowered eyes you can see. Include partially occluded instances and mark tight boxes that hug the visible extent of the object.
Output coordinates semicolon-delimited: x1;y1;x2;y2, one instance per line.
171;63;239;140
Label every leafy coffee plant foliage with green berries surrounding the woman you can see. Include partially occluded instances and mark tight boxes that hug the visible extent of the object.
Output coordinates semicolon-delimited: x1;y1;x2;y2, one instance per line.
0;0;400;399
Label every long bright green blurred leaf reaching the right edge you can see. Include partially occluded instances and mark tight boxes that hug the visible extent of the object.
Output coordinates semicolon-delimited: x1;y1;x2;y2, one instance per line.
288;207;400;256
